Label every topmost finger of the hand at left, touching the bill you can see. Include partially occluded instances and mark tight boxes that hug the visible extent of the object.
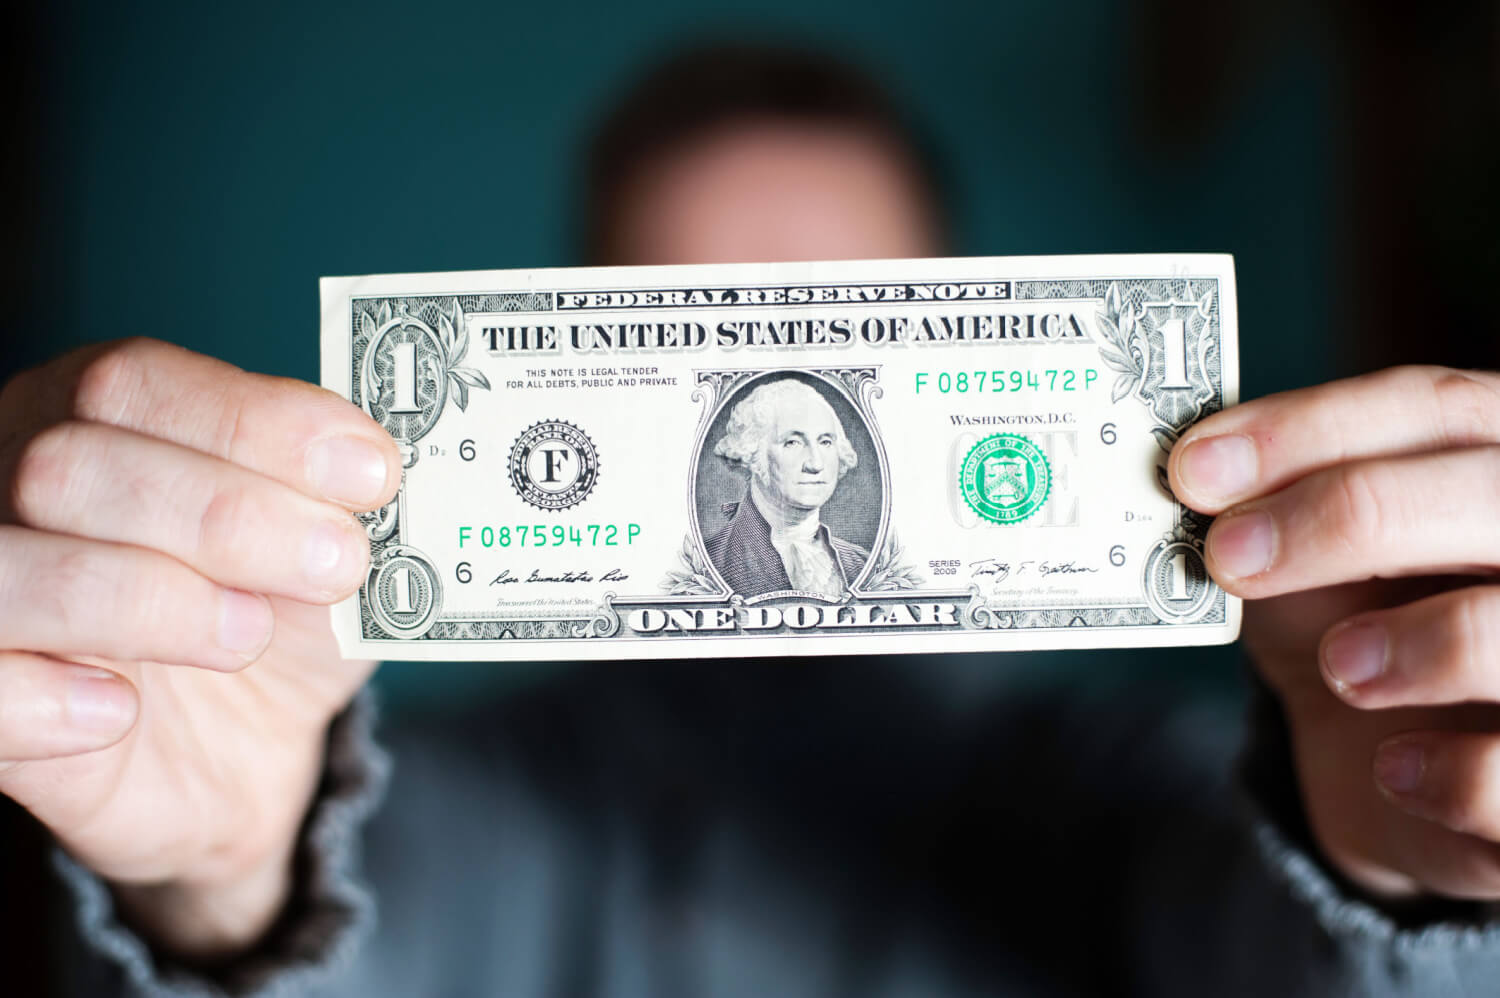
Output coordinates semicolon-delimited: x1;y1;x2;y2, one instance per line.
0;339;401;509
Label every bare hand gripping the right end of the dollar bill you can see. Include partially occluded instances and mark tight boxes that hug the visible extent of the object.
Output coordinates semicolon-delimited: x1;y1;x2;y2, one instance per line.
1169;368;1500;899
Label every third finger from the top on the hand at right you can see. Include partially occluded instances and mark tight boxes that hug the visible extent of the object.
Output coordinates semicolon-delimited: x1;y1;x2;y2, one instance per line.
1319;585;1500;708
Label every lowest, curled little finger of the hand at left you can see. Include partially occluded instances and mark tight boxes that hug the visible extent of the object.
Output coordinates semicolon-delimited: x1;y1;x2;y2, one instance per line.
0;651;140;770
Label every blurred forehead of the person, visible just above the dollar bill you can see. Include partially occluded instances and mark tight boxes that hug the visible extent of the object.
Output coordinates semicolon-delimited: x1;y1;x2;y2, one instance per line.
606;120;939;264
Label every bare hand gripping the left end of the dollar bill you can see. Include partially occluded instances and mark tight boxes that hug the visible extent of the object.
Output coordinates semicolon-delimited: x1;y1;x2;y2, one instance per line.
0;339;401;956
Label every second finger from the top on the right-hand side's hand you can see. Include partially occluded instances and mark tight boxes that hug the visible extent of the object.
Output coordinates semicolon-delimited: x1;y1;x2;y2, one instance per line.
1206;446;1500;599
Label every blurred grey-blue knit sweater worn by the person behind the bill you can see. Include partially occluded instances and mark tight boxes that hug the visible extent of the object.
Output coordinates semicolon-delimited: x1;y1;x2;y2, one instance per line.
17;659;1500;998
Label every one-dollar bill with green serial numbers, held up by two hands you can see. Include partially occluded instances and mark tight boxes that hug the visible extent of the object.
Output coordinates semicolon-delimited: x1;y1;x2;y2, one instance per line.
323;255;1241;660
